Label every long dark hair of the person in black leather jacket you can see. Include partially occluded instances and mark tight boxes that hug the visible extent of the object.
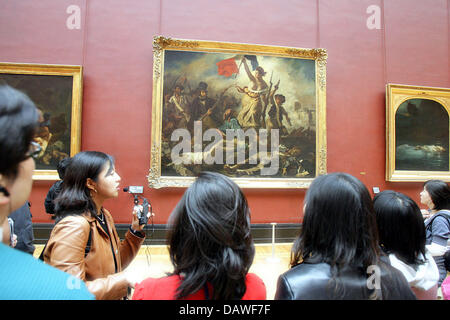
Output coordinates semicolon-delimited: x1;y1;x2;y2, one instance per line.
291;173;379;269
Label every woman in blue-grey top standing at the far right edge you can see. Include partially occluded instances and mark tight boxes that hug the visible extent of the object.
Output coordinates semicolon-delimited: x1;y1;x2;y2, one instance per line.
420;180;450;286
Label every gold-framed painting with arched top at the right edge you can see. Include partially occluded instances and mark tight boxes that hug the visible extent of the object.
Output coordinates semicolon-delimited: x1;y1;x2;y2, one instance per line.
386;84;450;181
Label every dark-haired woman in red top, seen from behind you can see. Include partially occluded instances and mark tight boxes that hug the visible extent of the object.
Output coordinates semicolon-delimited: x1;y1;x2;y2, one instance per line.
133;172;266;300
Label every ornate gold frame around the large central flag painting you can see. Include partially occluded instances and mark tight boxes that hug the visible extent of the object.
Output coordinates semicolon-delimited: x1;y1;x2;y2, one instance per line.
147;35;328;189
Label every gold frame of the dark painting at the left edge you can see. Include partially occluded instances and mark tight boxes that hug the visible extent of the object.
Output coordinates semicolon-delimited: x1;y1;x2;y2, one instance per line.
0;62;83;180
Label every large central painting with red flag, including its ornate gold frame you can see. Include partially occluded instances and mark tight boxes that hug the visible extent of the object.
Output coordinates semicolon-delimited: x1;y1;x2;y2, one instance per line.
148;36;327;188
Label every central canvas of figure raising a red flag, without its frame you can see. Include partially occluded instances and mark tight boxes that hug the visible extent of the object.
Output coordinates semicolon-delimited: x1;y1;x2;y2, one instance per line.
161;50;316;178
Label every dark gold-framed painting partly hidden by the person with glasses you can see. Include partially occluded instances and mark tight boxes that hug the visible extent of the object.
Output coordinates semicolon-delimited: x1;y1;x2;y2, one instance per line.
0;63;82;180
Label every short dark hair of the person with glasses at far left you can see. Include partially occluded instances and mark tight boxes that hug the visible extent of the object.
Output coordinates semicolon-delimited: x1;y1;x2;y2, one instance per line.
0;85;38;178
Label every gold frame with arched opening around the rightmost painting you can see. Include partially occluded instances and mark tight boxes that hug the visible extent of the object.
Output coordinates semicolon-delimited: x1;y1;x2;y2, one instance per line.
386;83;450;182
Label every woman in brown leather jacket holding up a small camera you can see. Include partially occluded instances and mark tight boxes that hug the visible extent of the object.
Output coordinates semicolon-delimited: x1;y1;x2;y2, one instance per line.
44;151;144;299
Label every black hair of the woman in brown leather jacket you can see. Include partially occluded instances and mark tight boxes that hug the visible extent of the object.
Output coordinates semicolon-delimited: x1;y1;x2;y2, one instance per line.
55;151;114;222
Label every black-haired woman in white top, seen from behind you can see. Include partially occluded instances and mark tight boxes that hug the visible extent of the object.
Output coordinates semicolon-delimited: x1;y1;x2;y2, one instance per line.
373;190;439;300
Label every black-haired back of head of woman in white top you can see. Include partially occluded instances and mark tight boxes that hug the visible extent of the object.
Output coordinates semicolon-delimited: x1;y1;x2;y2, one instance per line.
373;190;425;265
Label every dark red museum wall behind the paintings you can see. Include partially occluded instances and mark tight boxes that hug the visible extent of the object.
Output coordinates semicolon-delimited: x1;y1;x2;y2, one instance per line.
0;0;450;224
